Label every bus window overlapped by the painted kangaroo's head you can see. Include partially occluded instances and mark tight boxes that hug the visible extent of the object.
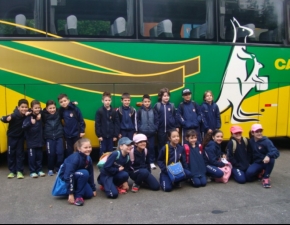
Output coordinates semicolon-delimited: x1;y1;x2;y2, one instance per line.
219;0;285;44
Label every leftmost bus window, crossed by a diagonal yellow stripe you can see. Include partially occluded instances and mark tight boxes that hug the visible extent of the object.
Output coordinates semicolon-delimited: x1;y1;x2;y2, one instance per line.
0;0;46;37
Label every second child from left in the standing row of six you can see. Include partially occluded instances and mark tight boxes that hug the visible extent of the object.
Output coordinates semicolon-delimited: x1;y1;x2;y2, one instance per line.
117;93;137;140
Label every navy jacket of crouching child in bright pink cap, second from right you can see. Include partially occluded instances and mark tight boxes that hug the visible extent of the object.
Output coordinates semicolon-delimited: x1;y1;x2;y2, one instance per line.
227;137;252;171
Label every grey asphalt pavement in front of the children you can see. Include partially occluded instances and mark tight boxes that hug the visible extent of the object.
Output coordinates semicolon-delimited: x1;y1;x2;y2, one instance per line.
0;139;290;224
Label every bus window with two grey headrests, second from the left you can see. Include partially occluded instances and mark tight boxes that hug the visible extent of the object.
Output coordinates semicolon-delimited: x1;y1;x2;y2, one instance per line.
50;0;134;37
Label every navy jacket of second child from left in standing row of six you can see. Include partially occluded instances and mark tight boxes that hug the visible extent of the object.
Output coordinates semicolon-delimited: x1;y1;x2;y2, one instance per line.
117;106;137;132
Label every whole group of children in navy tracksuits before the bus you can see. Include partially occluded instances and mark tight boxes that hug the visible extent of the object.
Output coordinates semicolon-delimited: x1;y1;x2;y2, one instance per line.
1;88;279;205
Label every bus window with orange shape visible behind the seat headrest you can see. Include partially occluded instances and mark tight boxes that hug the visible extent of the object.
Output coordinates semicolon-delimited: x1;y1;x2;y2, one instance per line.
139;0;215;40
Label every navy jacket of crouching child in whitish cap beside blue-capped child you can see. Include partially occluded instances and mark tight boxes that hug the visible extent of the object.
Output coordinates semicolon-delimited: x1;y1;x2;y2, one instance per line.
129;146;151;172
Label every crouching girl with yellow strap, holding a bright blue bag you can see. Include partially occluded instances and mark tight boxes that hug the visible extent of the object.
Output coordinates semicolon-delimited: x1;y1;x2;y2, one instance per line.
158;130;192;192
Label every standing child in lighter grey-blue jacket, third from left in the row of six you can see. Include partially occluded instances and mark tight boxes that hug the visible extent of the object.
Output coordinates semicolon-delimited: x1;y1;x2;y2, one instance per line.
137;94;158;169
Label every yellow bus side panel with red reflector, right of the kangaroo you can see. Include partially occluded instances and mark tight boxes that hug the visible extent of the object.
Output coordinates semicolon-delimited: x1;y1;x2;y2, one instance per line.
257;83;279;137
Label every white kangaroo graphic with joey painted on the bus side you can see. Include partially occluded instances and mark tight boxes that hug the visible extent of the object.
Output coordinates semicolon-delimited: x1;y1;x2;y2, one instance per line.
217;18;268;124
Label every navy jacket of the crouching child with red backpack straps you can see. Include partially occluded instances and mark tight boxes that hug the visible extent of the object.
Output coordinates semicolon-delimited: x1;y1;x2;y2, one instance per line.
186;142;206;177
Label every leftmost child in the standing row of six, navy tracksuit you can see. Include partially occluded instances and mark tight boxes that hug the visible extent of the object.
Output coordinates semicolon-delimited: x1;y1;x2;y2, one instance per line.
95;92;120;155
